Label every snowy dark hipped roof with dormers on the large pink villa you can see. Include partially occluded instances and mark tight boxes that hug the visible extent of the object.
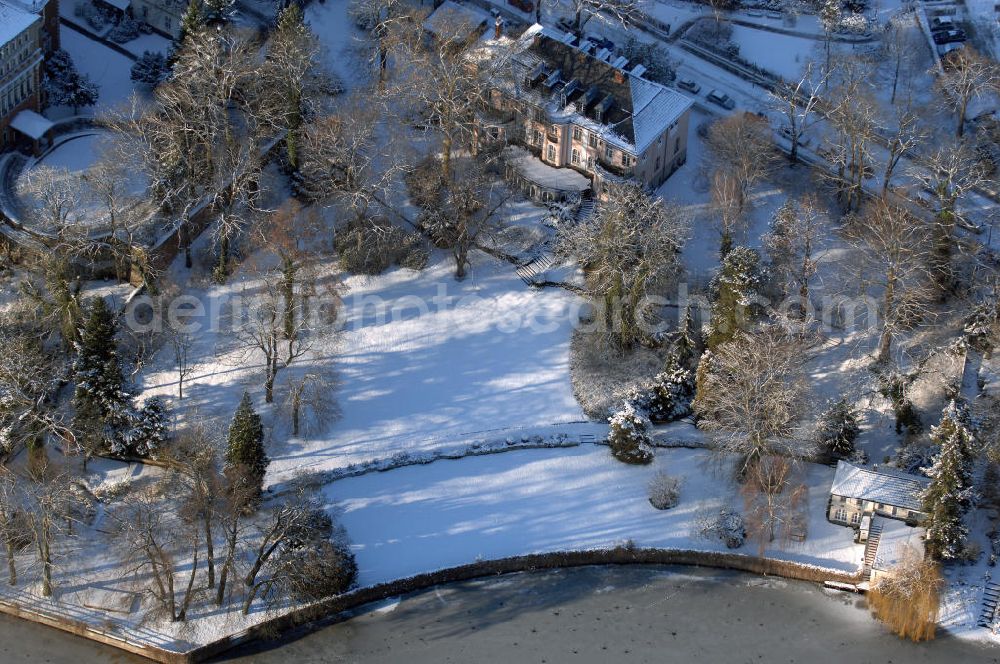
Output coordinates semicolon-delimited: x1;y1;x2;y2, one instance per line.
500;23;694;154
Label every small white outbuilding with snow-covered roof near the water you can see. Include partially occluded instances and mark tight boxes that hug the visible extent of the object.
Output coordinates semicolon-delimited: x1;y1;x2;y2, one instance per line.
827;461;930;529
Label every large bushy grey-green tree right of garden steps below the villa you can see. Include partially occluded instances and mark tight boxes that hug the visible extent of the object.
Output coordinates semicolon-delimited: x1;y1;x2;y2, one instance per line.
559;182;689;350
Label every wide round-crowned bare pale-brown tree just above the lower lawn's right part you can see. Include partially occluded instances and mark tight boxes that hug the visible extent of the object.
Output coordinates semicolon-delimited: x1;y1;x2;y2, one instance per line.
695;328;814;479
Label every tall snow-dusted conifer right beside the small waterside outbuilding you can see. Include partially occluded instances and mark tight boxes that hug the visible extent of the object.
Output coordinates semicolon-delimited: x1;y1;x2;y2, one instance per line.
921;401;974;560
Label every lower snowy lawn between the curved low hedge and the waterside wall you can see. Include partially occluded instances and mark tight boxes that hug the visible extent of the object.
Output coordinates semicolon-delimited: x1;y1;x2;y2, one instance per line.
325;445;863;584
